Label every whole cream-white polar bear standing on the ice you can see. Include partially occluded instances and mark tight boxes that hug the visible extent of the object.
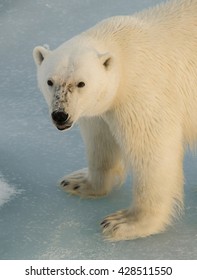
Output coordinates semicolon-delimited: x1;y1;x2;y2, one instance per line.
33;0;197;241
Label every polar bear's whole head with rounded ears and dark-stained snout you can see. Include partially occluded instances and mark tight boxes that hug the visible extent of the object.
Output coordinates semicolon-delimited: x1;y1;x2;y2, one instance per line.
33;41;118;130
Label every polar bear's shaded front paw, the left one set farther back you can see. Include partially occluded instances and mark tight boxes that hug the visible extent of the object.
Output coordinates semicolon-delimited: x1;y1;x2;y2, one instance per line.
60;169;105;198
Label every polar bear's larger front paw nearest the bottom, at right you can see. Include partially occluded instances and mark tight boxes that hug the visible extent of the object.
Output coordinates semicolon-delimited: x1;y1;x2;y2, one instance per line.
101;209;162;241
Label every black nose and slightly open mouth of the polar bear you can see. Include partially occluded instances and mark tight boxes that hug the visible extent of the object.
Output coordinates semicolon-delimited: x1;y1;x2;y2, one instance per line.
51;110;72;130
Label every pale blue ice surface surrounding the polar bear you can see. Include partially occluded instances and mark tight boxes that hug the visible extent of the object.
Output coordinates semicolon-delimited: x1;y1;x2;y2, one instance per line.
0;0;197;260
